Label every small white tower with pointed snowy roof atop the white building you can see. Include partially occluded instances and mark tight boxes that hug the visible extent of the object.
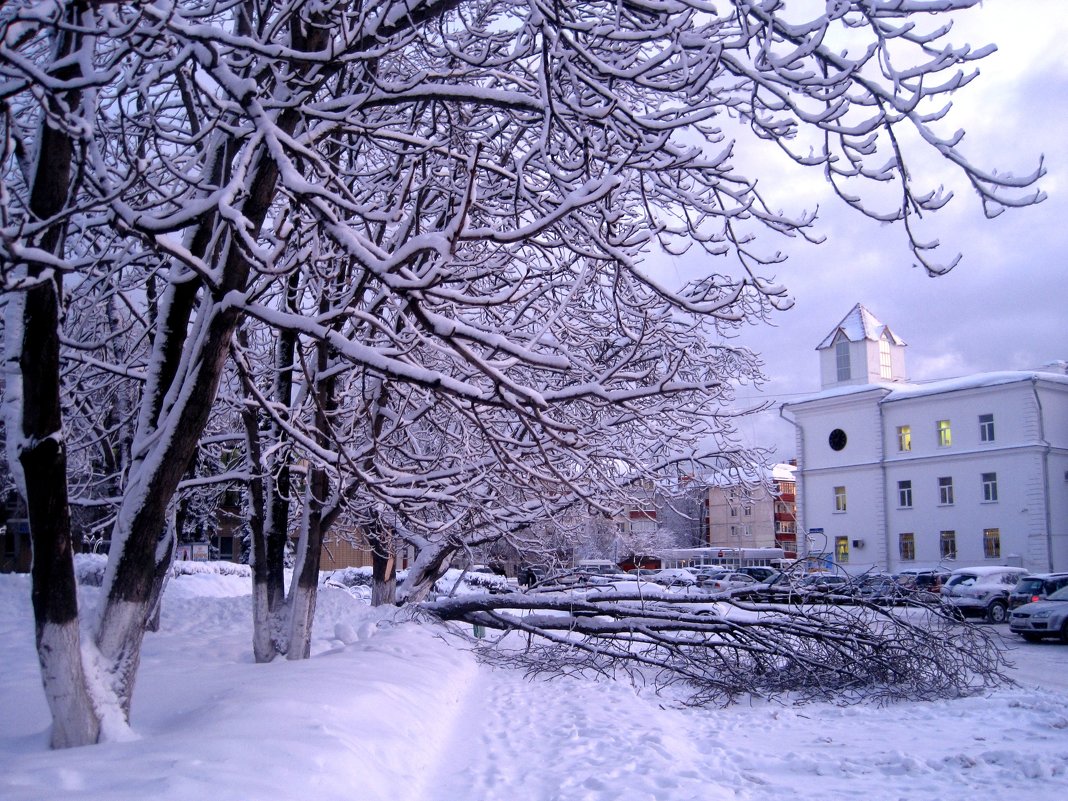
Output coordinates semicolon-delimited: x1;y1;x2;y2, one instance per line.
816;303;906;390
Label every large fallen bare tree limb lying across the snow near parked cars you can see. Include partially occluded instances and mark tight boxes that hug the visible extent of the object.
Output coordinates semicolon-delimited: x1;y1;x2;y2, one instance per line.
421;585;1010;706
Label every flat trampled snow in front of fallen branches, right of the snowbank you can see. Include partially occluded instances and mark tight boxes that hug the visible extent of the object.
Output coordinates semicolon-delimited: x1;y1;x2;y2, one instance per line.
420;632;1068;801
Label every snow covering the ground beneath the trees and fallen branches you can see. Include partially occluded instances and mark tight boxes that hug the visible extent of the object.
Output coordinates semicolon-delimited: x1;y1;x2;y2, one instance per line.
0;575;1068;801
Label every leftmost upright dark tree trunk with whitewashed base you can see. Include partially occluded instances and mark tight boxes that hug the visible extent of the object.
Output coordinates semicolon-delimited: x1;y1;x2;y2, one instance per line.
4;4;100;748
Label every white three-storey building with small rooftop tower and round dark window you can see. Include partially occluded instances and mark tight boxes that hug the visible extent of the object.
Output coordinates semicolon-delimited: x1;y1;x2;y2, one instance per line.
782;304;1068;572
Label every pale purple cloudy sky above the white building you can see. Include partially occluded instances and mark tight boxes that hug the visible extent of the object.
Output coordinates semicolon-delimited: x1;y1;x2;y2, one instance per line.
649;0;1068;459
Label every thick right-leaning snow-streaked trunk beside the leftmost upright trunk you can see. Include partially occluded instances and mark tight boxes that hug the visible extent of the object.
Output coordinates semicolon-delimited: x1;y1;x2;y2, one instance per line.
96;10;326;717
